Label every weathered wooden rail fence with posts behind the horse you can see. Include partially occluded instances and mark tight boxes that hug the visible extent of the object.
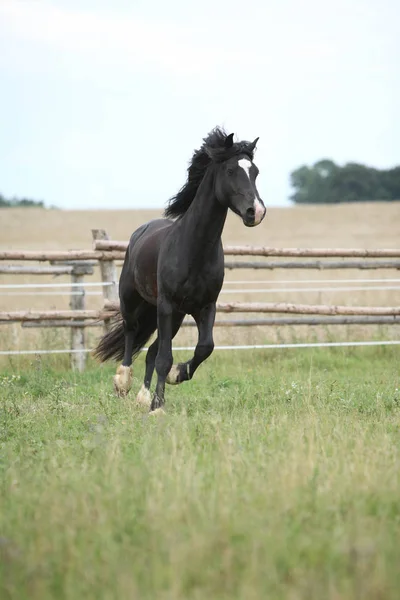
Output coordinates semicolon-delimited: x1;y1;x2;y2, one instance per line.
0;229;400;370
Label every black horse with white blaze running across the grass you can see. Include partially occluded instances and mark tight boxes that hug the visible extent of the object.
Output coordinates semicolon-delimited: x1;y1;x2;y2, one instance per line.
94;128;266;411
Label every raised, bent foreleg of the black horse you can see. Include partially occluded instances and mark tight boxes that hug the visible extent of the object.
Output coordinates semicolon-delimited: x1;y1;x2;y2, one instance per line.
166;303;216;385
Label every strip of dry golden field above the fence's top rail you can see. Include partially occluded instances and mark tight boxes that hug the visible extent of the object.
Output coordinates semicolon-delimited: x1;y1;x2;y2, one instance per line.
0;202;400;250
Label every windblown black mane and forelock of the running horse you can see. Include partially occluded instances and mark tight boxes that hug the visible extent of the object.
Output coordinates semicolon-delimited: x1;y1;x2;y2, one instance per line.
164;127;254;218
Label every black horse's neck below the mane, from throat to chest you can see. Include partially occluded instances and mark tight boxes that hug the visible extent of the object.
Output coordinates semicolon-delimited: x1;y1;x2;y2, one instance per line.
180;167;228;262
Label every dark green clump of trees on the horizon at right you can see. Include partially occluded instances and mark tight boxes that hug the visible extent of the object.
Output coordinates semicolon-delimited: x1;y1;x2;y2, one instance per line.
290;159;400;204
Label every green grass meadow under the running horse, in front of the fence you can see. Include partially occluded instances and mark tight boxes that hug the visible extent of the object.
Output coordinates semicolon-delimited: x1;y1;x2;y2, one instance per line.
0;348;400;600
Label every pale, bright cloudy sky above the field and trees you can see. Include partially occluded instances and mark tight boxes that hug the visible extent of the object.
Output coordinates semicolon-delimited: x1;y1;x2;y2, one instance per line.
0;0;400;209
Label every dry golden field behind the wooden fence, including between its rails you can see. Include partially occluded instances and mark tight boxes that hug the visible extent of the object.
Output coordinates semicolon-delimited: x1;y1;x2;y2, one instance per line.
0;202;400;358
